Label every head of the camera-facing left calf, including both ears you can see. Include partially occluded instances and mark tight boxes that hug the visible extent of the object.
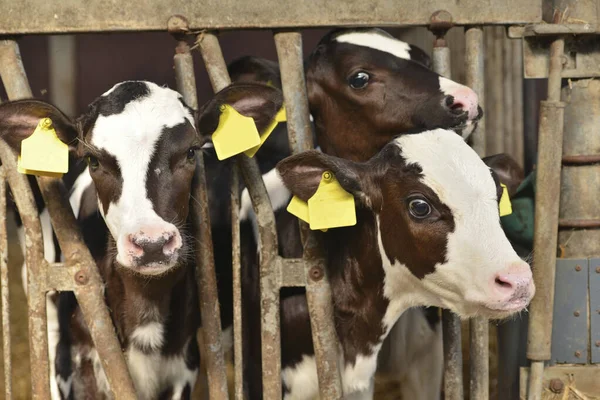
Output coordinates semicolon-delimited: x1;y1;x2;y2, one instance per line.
0;81;283;275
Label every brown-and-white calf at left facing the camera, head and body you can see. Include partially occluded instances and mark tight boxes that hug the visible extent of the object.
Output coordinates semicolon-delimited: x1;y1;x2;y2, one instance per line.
0;81;282;399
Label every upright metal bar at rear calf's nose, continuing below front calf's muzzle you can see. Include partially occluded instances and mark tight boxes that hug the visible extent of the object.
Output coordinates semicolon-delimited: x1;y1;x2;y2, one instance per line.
465;27;489;400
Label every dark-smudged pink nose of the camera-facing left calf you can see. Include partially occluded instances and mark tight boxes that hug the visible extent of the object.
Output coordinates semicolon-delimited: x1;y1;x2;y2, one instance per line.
125;231;182;264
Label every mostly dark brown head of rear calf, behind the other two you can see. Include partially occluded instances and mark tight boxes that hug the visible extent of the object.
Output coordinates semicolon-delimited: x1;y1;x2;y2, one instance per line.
306;29;483;161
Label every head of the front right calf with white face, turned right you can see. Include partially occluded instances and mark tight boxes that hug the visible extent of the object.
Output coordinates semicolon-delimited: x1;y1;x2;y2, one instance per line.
278;129;535;318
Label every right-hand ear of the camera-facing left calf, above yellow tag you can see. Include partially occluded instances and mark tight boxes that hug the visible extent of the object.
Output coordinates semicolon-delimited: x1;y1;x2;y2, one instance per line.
196;82;283;137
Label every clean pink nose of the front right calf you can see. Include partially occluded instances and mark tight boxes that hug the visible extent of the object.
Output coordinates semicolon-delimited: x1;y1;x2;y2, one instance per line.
493;262;535;303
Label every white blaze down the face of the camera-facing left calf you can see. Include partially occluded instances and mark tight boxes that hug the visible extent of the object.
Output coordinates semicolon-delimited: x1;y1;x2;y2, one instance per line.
91;82;194;265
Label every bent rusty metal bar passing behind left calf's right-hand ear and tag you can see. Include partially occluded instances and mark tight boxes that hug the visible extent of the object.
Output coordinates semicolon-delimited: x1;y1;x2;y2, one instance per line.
197;33;281;400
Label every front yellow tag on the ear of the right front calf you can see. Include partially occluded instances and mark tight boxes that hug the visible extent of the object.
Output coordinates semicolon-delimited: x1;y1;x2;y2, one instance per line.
308;171;356;230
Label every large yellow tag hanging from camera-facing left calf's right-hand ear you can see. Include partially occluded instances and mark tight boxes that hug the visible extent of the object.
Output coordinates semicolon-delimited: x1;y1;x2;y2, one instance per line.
212;104;260;160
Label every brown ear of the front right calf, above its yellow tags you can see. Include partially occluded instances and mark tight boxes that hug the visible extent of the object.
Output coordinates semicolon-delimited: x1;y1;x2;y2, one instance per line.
277;150;368;201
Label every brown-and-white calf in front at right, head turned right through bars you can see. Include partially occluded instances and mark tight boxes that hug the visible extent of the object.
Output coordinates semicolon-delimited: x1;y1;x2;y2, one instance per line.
277;129;535;399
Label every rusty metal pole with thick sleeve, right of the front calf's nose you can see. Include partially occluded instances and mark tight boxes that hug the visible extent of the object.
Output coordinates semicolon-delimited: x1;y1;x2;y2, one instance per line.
527;25;565;400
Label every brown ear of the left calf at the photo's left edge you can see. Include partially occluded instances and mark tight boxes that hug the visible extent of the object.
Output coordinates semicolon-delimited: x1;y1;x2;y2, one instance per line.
0;100;78;152
